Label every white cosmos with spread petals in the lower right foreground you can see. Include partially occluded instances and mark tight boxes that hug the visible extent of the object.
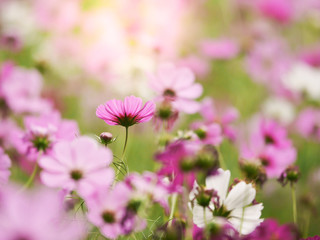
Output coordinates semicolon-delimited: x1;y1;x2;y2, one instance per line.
189;168;263;234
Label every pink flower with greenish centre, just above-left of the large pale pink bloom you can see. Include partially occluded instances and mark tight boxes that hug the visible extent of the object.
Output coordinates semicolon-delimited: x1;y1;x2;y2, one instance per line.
18;111;79;161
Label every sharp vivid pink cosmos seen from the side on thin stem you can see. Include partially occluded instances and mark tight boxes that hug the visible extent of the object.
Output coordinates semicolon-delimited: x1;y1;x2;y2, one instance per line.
96;96;155;127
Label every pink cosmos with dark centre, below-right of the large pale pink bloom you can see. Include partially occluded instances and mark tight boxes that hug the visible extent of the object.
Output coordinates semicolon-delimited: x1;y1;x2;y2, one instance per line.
87;182;145;239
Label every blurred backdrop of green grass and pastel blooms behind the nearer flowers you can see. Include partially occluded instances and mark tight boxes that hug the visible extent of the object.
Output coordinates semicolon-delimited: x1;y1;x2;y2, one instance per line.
0;0;320;235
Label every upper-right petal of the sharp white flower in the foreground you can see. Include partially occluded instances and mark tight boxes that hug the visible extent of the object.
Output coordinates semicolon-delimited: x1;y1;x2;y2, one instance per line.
224;182;256;210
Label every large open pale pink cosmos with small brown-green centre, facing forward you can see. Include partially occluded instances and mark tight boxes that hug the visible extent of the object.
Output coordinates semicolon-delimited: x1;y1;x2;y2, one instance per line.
39;137;114;196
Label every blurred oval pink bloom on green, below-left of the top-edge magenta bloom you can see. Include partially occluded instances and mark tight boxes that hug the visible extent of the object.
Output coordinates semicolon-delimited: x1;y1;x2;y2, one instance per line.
200;39;239;60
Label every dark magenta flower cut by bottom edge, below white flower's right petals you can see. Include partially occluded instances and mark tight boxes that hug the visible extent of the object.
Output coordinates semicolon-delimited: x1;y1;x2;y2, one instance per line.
243;219;299;240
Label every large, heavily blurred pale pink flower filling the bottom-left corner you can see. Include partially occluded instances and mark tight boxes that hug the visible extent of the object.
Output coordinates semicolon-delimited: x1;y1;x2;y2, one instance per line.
0;188;86;240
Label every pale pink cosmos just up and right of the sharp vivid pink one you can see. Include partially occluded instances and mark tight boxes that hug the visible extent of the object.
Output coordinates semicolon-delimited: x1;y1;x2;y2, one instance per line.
150;64;202;114
